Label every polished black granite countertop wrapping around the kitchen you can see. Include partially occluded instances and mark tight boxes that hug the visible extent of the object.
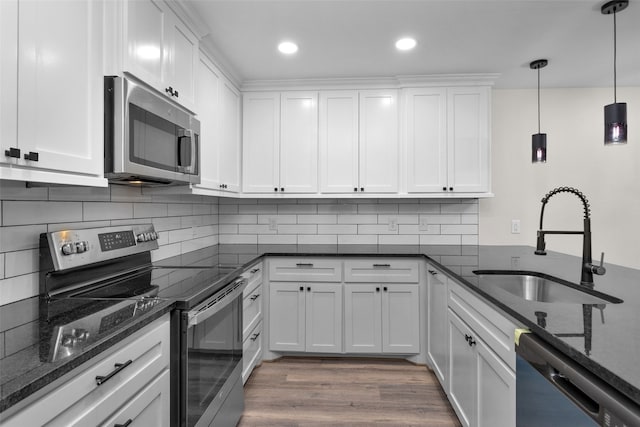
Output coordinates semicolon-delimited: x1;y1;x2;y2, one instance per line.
0;245;640;412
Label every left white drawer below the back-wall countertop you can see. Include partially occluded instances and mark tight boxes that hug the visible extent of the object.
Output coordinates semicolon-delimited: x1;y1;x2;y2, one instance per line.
269;258;342;282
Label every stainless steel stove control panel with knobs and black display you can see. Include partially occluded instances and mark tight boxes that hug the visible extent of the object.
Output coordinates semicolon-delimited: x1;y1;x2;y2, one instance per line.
40;224;160;271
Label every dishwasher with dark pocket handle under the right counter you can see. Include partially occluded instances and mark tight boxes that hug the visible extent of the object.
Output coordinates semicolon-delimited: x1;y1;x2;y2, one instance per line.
516;334;640;427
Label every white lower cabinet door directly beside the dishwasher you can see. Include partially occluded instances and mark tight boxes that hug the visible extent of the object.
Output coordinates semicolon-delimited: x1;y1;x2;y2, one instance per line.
476;339;516;427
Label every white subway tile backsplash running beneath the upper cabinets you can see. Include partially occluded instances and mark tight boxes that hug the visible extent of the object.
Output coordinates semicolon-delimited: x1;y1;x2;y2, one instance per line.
0;181;478;359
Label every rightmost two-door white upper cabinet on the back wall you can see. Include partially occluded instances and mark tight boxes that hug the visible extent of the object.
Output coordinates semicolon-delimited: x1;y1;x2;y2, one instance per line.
404;86;490;193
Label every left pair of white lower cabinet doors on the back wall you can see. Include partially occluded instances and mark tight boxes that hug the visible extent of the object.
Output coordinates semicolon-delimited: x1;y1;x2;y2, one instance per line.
269;282;342;353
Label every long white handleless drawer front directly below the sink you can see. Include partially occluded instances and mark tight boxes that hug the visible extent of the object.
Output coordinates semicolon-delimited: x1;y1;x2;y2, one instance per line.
448;280;516;370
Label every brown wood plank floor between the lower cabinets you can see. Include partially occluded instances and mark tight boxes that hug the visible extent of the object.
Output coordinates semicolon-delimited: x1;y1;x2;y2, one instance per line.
238;357;460;427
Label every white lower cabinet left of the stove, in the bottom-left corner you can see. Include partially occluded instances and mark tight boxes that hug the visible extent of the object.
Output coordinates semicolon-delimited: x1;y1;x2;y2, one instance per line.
3;314;170;427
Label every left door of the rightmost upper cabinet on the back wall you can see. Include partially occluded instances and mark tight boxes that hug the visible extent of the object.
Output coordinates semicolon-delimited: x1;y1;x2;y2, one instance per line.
404;88;447;193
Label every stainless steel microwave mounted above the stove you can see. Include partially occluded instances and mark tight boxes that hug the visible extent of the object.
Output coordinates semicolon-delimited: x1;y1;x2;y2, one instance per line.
104;76;200;186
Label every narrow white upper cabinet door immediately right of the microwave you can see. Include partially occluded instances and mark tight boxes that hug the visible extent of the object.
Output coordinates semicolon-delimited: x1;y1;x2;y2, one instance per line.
196;58;222;190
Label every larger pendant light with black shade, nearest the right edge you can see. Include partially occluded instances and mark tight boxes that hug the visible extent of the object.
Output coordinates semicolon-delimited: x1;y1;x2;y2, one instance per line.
601;0;629;145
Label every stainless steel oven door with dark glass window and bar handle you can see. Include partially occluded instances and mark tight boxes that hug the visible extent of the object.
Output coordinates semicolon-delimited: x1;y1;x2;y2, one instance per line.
180;279;246;427
